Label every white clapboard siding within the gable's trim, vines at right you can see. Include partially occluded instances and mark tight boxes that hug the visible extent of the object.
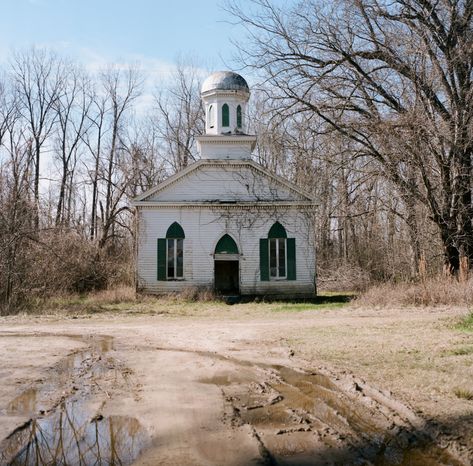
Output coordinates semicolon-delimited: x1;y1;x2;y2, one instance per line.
147;164;306;202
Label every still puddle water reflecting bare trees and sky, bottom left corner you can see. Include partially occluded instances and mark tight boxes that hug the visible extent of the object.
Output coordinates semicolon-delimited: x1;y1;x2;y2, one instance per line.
0;401;148;466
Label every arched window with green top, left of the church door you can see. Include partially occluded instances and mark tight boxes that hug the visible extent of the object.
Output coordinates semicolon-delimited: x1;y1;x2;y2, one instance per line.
158;222;185;280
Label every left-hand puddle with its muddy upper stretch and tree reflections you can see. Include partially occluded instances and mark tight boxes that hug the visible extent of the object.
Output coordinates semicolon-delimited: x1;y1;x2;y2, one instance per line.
0;335;149;466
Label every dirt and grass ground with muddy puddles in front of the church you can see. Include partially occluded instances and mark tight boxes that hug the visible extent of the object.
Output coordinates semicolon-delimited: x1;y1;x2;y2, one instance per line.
0;303;473;466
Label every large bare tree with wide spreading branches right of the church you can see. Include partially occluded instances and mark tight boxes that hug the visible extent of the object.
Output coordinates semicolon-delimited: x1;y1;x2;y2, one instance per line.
229;0;473;271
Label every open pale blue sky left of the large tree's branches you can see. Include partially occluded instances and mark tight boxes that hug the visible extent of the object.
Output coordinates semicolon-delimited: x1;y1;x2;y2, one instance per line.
0;0;249;77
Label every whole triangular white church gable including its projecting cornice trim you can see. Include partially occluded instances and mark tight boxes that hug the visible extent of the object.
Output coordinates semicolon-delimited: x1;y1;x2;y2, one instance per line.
133;159;313;203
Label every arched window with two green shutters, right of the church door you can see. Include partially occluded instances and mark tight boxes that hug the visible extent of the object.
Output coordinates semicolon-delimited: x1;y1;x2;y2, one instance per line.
260;222;296;281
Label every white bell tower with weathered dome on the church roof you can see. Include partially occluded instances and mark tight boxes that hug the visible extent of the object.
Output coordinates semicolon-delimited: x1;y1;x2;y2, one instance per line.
197;71;256;160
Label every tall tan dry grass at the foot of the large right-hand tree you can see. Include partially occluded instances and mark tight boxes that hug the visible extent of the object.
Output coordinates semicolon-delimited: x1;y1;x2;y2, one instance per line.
354;277;473;307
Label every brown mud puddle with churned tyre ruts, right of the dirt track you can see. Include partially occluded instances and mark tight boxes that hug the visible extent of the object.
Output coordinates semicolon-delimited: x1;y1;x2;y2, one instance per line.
196;354;465;466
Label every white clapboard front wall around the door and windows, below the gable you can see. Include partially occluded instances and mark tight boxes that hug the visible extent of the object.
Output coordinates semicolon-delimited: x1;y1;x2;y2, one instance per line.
137;207;315;296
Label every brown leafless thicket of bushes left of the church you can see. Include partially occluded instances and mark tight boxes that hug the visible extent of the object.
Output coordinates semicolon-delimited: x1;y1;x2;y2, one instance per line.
0;229;134;314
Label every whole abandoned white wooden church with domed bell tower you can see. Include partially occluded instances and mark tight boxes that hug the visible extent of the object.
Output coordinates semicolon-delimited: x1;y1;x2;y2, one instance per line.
133;71;316;297
